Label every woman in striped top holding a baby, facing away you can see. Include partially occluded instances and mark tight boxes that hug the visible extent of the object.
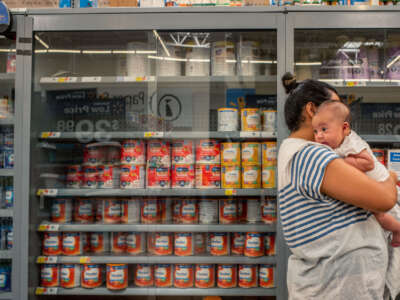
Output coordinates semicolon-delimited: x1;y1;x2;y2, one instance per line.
278;74;397;300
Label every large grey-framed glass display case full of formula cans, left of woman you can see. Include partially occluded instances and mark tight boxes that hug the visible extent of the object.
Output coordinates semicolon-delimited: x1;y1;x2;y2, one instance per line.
21;10;286;299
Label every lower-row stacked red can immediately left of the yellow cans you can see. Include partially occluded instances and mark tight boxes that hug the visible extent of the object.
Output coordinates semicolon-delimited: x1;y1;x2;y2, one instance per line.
196;164;221;189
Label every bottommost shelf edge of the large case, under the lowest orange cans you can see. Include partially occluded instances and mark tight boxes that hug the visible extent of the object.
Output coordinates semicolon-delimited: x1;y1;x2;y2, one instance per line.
36;287;276;296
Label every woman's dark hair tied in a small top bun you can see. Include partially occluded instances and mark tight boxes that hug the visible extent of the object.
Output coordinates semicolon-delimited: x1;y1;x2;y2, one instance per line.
282;73;337;131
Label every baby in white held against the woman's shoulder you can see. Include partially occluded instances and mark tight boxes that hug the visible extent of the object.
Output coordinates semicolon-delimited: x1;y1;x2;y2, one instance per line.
312;101;400;247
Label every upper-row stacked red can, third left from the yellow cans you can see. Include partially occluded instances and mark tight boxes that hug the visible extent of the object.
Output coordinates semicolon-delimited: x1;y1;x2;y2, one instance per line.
147;140;171;168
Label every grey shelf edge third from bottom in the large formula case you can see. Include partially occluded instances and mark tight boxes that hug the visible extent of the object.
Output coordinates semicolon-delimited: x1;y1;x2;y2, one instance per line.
38;222;276;232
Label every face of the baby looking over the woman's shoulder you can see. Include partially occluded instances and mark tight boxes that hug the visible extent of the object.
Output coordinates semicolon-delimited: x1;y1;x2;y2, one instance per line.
312;110;347;149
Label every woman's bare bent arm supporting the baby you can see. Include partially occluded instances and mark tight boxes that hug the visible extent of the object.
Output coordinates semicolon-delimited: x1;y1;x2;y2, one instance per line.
321;159;397;212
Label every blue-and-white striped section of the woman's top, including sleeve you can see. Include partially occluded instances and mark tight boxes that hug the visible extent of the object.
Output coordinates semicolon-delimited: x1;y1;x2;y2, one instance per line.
279;145;371;248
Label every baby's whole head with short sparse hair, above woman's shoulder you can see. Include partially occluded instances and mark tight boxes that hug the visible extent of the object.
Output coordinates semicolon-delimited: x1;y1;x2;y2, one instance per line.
312;100;350;149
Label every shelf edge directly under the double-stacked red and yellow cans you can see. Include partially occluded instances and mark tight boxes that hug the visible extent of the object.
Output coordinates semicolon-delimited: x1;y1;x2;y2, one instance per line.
37;188;276;197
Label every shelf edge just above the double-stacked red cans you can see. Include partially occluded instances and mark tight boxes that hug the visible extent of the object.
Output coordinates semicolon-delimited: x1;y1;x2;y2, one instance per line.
39;131;276;141
